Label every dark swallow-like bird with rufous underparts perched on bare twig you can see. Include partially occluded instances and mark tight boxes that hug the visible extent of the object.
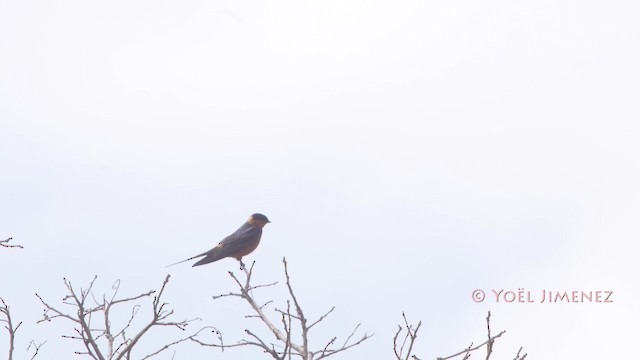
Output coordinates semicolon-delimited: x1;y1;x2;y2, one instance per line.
166;213;271;269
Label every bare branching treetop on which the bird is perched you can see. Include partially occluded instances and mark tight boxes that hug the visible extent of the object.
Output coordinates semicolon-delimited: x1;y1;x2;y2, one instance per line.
198;258;373;360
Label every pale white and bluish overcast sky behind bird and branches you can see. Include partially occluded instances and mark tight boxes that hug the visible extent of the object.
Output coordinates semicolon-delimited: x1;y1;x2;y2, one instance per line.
0;0;640;359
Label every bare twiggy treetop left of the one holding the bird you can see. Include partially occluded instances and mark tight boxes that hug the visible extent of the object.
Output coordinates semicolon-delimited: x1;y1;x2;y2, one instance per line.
36;275;216;360
